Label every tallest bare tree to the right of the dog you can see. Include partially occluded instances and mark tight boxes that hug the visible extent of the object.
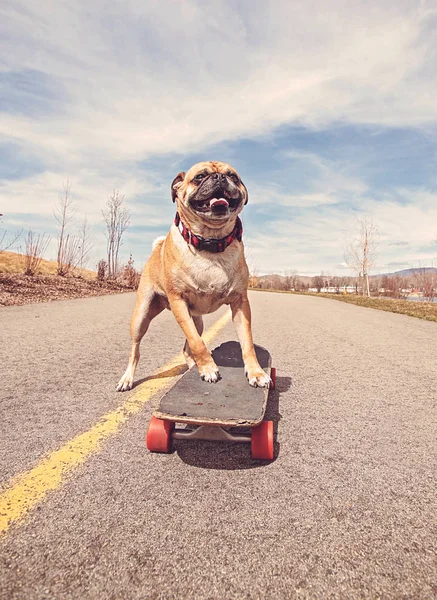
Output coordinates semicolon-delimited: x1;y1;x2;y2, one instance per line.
344;217;378;296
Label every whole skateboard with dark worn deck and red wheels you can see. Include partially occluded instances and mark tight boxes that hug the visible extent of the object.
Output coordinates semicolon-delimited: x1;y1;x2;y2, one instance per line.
146;342;276;460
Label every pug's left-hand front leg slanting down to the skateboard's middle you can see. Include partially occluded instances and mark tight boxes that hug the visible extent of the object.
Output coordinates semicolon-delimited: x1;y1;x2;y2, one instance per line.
168;295;220;383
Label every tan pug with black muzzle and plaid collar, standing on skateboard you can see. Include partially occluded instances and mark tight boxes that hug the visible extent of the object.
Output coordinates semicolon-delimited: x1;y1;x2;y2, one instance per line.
117;161;270;391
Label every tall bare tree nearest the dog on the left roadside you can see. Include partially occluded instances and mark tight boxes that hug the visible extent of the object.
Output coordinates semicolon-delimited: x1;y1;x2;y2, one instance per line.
102;190;130;279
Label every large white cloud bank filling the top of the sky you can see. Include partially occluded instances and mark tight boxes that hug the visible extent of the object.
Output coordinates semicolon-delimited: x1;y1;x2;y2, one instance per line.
2;0;437;166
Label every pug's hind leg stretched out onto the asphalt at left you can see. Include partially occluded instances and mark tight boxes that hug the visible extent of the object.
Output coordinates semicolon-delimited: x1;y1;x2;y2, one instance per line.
116;285;166;392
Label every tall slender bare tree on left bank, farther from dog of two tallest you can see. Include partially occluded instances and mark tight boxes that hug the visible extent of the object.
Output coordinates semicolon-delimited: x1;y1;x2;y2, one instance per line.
53;181;79;276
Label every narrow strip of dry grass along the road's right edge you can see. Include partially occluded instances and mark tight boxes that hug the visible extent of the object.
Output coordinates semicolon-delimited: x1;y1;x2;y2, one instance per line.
251;288;437;322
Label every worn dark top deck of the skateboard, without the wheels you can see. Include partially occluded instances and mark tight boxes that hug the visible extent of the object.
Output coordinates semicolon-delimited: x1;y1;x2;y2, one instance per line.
153;341;272;427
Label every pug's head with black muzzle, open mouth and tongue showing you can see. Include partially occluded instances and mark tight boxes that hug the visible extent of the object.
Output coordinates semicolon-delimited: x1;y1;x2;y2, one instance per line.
171;161;248;227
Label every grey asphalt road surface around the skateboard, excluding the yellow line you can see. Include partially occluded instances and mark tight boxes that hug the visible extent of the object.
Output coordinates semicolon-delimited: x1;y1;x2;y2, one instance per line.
0;293;437;600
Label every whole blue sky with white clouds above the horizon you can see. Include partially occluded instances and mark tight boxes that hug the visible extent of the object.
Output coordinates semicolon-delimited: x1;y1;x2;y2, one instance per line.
0;0;437;275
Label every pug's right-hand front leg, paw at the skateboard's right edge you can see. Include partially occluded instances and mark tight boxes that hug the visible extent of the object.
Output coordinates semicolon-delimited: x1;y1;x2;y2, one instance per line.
231;292;271;387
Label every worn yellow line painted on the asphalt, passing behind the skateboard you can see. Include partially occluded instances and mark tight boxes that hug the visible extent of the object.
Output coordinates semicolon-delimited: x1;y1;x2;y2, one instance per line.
0;311;231;536
